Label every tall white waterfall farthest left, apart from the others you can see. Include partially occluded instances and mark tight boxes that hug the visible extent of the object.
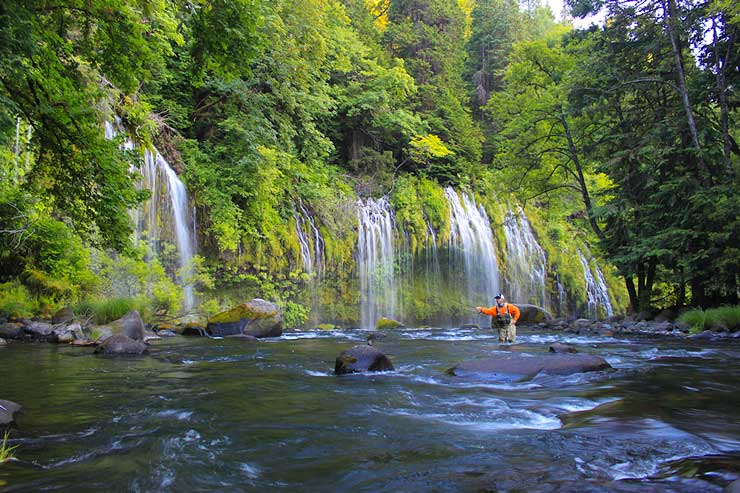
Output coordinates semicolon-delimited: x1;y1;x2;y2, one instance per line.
105;120;196;312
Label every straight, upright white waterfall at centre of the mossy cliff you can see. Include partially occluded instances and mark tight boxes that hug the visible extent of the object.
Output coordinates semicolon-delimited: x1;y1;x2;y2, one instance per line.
357;197;400;329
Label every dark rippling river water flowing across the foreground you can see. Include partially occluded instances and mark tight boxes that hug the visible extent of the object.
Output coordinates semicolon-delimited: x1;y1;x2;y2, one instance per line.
0;329;740;492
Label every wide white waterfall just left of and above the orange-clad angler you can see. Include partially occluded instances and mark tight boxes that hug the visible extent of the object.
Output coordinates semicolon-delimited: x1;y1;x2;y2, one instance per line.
445;187;500;307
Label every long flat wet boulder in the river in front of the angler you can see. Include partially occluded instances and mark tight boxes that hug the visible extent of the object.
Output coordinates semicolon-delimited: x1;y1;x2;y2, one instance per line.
447;353;611;377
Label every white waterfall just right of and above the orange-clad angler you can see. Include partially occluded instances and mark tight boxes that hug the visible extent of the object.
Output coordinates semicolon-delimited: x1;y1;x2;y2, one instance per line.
504;207;547;308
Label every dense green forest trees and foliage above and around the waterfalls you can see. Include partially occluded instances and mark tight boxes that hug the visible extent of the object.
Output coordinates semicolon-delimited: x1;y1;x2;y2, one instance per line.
0;0;740;320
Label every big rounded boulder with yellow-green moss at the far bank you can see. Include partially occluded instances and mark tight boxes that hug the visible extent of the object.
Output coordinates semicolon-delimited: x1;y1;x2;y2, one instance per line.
206;298;283;338
